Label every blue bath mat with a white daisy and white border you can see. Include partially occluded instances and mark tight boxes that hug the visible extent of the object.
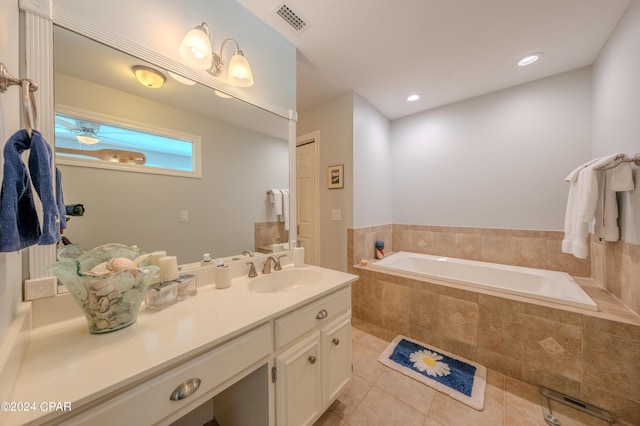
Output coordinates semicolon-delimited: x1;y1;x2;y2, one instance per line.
378;336;487;410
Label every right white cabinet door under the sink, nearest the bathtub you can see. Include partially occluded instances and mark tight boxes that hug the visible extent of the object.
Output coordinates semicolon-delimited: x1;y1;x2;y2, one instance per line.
320;311;352;407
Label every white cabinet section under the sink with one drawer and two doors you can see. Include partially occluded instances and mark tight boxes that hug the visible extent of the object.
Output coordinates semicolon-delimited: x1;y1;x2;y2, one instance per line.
273;286;351;426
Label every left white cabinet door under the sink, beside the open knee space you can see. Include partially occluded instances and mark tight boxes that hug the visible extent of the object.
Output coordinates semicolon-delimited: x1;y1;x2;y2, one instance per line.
275;332;322;426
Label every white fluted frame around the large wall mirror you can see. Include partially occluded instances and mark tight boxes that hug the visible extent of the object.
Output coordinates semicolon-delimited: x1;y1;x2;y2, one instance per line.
19;0;297;281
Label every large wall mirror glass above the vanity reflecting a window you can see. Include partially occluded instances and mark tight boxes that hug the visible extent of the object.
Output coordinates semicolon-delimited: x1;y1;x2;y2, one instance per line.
54;26;289;264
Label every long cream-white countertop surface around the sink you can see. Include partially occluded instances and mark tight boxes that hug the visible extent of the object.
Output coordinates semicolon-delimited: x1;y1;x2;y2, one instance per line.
6;265;357;425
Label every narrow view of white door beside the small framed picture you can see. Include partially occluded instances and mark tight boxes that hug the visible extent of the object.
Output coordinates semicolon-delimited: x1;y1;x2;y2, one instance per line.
296;132;318;265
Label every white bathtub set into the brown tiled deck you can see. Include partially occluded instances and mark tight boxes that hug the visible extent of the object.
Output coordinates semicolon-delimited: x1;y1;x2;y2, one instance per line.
370;252;598;311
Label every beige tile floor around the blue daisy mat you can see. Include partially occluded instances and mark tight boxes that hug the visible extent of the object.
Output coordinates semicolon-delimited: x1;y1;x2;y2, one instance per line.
315;320;620;426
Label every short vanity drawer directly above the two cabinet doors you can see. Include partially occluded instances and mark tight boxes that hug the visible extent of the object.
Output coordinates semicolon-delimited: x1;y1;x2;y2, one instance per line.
275;286;351;351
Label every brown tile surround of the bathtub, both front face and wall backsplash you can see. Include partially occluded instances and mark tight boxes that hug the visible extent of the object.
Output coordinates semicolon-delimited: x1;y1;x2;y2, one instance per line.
348;225;640;424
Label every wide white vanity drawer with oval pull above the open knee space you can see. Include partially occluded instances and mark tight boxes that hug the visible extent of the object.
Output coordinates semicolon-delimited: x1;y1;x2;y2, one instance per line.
64;324;272;426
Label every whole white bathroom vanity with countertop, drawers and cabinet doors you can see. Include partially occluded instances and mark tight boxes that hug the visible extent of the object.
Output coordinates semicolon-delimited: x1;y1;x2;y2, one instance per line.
3;266;357;425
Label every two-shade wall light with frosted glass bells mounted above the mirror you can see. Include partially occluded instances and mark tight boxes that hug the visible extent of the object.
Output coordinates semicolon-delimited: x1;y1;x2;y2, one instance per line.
179;22;253;87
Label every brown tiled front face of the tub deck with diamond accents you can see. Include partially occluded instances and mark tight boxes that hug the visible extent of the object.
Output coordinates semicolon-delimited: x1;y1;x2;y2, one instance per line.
352;267;640;424
